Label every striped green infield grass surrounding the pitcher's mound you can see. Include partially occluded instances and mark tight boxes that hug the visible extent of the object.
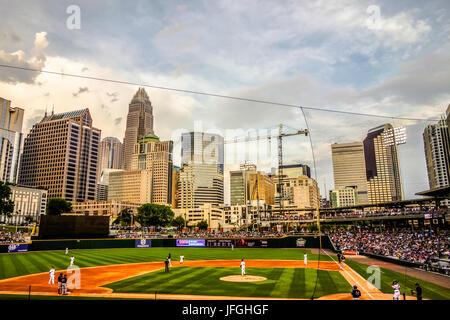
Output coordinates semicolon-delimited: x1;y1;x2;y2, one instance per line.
106;267;352;299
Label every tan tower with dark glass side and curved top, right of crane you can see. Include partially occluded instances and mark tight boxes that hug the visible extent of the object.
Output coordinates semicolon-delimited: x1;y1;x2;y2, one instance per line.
363;124;404;203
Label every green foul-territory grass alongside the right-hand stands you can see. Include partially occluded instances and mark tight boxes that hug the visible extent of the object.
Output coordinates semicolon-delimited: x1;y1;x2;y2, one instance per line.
346;259;450;300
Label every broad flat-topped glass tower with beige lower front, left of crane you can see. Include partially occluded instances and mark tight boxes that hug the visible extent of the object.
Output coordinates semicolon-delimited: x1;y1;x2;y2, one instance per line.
178;132;224;208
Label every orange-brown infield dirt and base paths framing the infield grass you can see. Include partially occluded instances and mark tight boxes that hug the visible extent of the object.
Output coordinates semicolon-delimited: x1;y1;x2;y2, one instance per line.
0;260;400;300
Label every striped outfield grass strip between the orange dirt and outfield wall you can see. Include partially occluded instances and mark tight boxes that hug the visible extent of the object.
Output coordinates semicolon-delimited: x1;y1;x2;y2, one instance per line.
0;248;331;279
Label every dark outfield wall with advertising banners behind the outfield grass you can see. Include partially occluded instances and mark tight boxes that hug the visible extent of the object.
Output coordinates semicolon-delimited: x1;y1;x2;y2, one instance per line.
0;235;332;253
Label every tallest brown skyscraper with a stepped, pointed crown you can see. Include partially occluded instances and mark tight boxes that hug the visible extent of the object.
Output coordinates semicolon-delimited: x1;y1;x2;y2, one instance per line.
123;88;154;170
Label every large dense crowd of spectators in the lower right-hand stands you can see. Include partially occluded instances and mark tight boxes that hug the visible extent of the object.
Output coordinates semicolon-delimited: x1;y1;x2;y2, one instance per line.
329;227;450;272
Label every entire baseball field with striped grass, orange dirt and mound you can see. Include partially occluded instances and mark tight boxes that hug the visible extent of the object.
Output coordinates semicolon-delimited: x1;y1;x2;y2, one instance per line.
0;248;450;300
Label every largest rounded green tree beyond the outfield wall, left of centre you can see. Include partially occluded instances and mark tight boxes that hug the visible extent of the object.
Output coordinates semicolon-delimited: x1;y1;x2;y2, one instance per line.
136;203;175;227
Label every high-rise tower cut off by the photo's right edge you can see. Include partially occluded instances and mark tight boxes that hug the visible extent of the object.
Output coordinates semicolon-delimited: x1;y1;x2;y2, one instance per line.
423;118;450;189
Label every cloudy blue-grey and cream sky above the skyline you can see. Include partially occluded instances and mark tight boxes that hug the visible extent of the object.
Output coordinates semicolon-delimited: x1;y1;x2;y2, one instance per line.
0;0;450;198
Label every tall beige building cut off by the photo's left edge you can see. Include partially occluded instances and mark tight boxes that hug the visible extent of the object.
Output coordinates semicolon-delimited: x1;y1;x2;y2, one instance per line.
0;97;24;182
